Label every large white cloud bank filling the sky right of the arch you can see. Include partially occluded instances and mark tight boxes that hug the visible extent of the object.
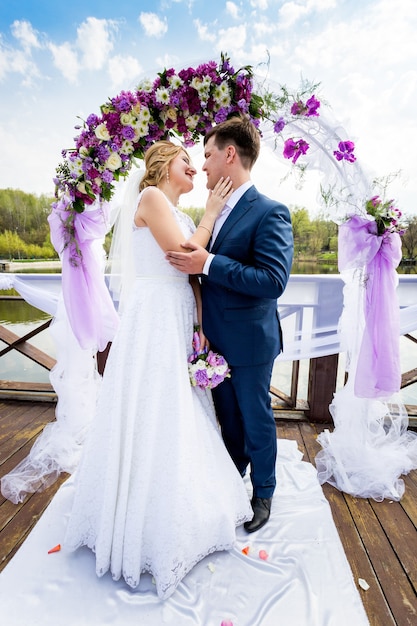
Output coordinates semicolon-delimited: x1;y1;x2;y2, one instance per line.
268;0;417;210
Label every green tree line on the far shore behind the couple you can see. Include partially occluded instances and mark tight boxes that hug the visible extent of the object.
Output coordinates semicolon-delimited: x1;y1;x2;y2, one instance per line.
0;189;417;260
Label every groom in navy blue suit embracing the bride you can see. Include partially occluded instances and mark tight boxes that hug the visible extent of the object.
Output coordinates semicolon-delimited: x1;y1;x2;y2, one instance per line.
167;117;293;532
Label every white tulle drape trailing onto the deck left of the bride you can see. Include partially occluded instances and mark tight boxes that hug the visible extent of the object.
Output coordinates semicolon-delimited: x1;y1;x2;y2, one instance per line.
0;276;101;504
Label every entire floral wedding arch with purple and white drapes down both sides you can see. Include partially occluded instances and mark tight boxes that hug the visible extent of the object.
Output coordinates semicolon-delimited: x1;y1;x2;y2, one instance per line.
2;55;417;501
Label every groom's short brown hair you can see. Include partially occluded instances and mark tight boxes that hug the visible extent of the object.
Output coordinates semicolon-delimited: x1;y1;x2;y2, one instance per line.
204;116;261;170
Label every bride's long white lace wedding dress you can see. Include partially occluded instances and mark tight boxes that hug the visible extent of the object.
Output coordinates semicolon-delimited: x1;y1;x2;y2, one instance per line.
63;193;253;599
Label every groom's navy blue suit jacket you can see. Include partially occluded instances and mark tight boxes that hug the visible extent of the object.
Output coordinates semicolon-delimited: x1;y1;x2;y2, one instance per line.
202;187;293;366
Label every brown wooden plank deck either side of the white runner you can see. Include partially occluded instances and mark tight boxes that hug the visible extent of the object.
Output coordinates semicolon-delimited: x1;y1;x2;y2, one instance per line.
0;400;417;626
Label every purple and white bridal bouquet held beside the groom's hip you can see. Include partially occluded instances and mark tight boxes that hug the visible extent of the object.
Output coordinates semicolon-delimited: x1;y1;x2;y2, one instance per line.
188;331;230;389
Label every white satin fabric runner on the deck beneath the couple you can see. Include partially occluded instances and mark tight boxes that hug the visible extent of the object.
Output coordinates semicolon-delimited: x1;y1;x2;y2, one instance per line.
0;440;369;626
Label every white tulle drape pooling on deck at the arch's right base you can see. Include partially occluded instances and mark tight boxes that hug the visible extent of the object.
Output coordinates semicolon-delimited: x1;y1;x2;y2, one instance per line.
316;270;417;501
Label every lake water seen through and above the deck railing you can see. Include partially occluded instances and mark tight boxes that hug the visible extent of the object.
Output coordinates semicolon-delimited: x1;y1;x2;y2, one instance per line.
0;264;417;405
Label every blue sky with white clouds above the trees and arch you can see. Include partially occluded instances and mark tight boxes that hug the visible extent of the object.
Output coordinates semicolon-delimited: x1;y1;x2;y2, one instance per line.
0;0;417;213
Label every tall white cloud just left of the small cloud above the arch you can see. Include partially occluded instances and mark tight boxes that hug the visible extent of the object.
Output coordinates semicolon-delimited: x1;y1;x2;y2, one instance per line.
77;17;116;70
